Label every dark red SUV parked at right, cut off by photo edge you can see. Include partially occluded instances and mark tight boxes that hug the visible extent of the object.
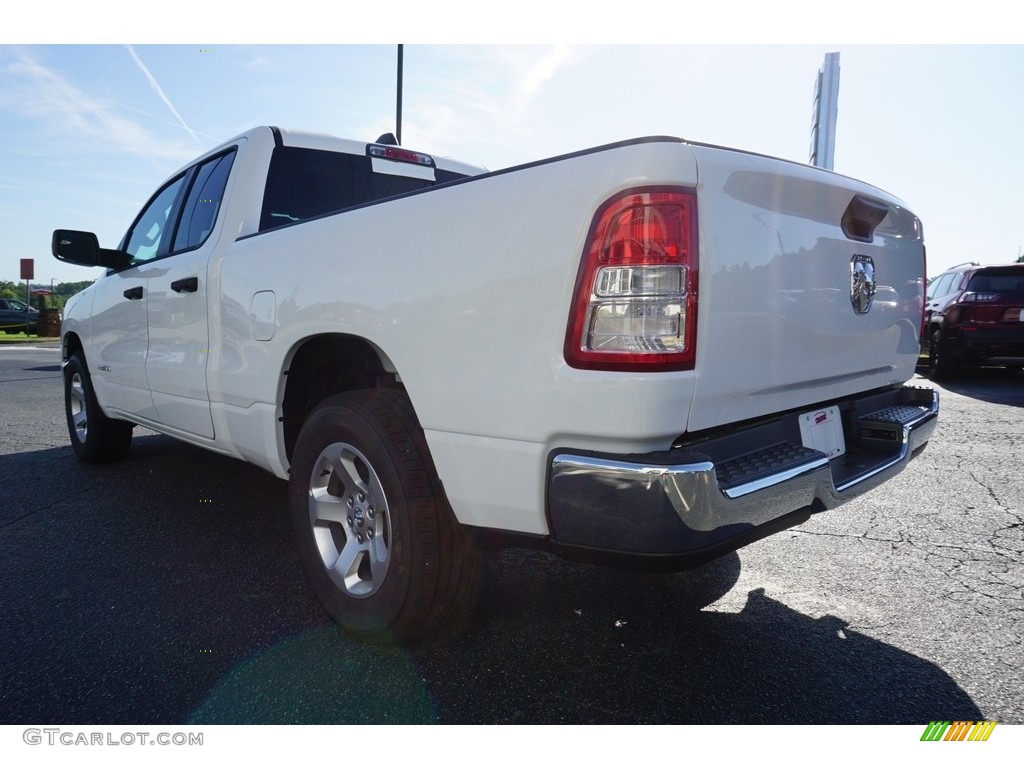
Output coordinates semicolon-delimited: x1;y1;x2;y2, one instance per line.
922;264;1024;379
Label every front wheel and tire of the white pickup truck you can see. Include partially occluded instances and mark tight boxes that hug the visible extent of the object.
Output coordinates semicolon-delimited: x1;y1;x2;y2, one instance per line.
63;352;135;464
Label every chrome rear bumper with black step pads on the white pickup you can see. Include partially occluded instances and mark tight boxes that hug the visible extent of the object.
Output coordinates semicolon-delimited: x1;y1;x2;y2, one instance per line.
548;387;939;564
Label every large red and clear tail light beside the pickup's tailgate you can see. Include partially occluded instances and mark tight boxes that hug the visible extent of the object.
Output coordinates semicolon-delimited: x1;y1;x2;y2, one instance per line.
564;187;697;371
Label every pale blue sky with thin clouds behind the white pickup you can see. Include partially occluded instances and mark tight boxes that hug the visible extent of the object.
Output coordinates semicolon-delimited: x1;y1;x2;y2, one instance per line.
0;9;1024;283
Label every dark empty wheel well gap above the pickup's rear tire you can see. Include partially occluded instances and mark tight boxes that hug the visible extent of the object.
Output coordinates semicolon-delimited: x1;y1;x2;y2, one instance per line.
281;334;401;461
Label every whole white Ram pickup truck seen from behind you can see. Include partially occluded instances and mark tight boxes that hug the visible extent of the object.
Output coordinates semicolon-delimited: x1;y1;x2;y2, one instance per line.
52;127;938;641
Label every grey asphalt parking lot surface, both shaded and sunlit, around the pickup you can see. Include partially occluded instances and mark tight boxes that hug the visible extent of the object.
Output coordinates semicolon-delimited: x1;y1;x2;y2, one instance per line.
0;345;1024;727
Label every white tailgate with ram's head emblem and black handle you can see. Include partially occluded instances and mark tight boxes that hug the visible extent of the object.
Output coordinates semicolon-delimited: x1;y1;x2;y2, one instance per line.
688;145;925;431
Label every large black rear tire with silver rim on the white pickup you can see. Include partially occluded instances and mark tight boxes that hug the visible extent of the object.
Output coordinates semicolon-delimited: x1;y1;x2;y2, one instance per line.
289;389;479;642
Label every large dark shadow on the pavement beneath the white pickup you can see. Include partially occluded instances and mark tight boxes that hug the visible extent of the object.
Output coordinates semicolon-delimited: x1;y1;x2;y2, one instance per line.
0;436;982;724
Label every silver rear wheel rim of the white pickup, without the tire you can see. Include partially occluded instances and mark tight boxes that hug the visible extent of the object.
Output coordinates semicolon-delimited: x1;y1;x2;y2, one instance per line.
309;442;391;598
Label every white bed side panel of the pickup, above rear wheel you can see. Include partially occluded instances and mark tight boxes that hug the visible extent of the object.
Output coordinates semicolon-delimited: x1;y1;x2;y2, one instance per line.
214;141;696;534
